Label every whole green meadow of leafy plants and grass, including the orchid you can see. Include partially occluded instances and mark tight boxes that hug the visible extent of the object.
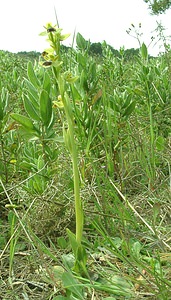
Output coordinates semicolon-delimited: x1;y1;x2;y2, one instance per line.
0;23;171;300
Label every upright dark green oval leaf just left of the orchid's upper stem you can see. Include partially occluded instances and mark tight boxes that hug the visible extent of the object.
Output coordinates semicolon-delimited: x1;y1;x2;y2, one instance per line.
40;90;52;127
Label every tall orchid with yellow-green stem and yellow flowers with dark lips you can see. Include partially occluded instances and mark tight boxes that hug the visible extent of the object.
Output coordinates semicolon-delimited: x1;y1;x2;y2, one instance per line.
41;23;86;273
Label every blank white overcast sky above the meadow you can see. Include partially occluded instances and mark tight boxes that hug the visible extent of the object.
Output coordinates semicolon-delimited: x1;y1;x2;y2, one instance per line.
0;0;171;55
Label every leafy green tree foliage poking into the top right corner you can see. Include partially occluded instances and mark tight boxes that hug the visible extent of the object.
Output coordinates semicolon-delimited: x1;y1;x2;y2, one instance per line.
144;0;171;15
